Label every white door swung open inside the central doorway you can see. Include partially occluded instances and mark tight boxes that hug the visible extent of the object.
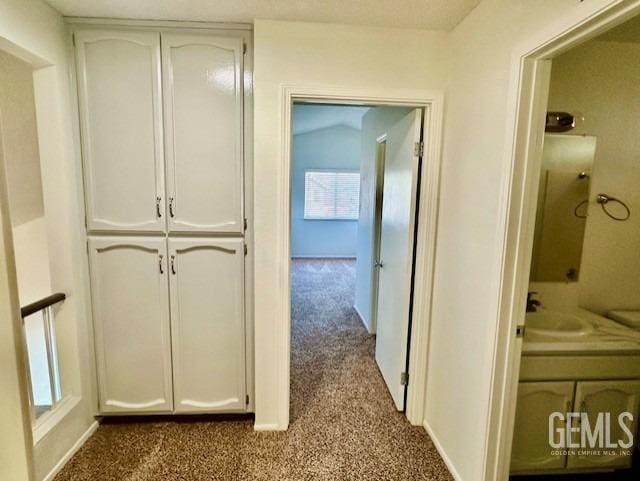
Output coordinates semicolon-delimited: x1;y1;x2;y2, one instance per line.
376;109;422;411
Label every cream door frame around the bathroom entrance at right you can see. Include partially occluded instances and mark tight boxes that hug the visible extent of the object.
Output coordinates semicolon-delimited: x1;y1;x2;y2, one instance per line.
483;0;640;481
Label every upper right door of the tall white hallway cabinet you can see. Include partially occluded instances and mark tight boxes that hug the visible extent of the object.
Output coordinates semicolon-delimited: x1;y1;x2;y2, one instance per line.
162;33;243;233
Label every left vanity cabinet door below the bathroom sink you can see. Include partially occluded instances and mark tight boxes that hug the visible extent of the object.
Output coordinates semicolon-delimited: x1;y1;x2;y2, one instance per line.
511;381;575;472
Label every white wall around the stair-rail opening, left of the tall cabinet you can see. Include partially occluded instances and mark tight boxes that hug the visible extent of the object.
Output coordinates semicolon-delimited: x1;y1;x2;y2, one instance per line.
0;0;94;479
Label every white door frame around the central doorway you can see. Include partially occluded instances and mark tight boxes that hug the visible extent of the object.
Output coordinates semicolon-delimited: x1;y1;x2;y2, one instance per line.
275;85;444;429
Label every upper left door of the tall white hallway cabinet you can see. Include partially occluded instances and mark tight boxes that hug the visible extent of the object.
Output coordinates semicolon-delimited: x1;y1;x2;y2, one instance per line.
75;30;166;232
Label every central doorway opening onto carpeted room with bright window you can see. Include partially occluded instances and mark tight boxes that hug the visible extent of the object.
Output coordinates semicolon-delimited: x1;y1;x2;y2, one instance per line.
290;101;433;432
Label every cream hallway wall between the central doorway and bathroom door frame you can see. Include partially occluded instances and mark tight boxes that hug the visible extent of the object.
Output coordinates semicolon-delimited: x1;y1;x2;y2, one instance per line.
426;0;612;481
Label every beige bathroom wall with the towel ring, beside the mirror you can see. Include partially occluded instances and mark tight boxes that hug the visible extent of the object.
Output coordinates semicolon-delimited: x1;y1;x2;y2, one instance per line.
549;40;640;314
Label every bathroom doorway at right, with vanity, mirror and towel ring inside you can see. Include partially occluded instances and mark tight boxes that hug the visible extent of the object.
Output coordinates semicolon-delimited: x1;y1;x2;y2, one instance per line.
496;7;640;481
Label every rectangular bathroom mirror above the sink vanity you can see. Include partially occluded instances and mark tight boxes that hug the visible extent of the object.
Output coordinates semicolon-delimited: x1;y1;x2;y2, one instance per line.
531;133;596;282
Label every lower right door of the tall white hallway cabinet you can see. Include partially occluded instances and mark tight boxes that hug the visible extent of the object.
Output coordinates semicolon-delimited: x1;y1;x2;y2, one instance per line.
169;239;246;412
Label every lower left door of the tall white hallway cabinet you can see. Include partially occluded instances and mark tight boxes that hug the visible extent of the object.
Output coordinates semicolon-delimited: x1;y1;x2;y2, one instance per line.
89;237;173;414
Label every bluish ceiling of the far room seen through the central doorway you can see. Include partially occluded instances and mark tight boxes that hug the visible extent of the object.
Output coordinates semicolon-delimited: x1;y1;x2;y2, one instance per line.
293;104;369;135
